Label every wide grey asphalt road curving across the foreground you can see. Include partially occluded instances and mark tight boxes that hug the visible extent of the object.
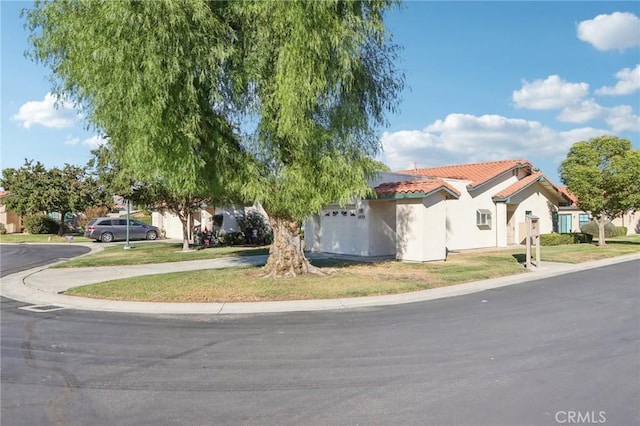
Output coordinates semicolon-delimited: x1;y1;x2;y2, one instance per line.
0;251;640;426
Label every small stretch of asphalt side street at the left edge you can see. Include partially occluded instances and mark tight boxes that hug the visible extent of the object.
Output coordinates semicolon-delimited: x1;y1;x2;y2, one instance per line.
0;244;90;277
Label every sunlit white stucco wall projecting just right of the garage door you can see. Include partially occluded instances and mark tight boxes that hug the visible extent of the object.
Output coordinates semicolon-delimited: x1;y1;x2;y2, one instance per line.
396;192;447;262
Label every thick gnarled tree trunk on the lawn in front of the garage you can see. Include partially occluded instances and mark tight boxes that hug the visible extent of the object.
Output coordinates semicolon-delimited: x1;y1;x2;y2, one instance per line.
263;217;325;277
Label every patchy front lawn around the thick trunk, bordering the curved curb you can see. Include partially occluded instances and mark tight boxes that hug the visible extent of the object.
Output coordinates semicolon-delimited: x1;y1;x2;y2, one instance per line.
65;254;525;302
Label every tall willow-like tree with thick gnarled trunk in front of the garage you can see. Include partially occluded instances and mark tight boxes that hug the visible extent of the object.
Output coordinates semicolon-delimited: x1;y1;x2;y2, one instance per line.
232;0;403;276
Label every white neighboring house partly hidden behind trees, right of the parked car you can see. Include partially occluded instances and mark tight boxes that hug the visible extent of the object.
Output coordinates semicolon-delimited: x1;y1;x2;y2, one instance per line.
151;204;269;239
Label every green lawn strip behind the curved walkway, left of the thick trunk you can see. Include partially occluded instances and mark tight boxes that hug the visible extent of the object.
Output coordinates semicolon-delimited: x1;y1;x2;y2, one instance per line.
54;242;269;268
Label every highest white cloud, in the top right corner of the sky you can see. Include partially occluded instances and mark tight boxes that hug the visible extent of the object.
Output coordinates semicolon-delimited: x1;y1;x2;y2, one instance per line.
577;12;640;50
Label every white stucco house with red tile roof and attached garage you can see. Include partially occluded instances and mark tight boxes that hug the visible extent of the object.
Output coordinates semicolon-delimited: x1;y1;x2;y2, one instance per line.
305;160;567;262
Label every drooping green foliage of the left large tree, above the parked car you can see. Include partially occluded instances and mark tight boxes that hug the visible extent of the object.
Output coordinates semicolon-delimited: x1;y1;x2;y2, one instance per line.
27;0;242;192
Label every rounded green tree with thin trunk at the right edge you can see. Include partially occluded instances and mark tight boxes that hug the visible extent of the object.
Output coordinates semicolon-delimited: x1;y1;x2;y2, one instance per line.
558;136;640;246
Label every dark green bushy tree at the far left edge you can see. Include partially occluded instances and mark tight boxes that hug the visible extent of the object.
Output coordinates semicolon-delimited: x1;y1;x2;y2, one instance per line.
0;160;105;235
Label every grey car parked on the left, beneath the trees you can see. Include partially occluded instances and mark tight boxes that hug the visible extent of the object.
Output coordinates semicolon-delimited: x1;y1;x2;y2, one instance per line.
84;217;160;243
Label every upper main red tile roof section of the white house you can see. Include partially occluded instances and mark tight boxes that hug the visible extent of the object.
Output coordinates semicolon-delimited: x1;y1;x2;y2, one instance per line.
400;160;531;188
